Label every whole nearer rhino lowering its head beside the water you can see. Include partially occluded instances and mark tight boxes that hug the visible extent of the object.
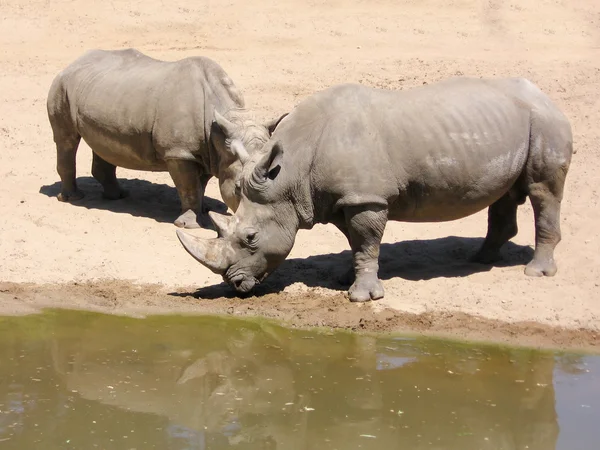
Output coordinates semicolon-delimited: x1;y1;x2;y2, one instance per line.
177;78;572;301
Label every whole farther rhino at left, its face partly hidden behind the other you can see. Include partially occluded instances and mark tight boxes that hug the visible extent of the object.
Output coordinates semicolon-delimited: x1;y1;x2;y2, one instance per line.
47;49;280;228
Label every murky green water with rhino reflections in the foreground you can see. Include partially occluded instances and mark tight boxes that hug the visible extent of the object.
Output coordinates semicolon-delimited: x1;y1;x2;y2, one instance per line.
0;311;600;450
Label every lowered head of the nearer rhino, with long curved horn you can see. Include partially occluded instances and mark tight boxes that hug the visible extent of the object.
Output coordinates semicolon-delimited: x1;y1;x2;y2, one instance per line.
176;142;299;293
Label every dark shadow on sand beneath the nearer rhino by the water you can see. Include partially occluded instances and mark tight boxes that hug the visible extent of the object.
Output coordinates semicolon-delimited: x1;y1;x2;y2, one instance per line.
171;236;533;300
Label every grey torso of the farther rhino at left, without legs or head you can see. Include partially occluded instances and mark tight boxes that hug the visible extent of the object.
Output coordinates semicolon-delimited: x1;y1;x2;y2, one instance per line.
49;49;243;170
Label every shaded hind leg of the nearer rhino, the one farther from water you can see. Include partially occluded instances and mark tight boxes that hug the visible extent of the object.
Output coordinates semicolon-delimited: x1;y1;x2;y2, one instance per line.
471;192;523;264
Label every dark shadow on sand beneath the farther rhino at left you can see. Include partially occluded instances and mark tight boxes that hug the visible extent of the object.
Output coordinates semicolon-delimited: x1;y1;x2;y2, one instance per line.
39;177;227;223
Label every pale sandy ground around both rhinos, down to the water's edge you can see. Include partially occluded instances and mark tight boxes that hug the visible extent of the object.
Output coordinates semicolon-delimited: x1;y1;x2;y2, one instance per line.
0;0;600;348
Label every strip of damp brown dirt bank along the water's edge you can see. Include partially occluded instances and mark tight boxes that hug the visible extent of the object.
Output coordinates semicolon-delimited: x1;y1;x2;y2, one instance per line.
0;281;600;352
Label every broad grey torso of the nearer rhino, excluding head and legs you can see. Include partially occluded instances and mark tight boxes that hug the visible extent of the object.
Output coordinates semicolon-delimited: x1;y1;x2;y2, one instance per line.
282;78;544;221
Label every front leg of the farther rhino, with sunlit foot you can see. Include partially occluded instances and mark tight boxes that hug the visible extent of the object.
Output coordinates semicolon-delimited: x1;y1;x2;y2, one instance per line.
167;159;212;229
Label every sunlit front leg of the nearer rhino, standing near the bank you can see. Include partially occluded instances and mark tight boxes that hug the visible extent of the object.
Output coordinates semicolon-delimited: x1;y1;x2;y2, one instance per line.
344;205;387;302
